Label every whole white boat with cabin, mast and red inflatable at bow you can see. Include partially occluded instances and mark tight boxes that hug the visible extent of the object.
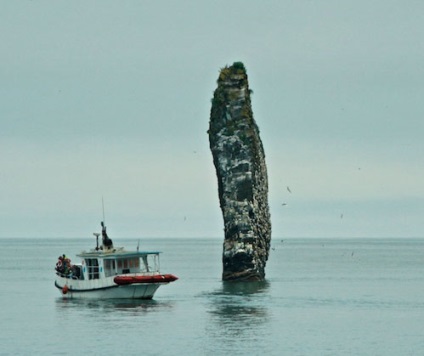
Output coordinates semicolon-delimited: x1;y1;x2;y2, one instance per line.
55;221;178;299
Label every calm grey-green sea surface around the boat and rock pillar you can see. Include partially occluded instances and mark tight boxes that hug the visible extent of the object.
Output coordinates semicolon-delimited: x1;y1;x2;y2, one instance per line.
0;238;424;355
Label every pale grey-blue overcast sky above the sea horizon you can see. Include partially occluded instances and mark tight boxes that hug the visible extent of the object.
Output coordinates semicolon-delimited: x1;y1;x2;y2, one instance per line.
0;0;424;239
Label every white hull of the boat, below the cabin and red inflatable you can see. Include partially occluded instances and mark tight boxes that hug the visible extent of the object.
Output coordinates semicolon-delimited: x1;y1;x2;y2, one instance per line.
55;276;167;299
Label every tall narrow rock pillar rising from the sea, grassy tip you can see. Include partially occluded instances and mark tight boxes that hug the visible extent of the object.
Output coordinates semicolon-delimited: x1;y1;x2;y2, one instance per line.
208;62;271;281
